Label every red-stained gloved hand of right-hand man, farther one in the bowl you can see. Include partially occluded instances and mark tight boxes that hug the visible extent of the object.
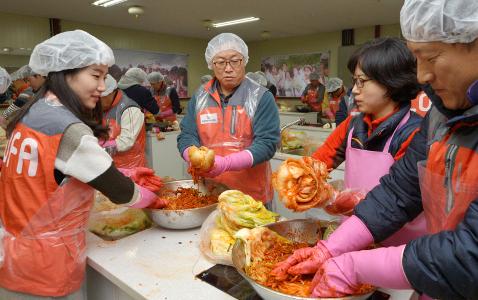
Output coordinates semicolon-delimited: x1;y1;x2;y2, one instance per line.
271;241;332;280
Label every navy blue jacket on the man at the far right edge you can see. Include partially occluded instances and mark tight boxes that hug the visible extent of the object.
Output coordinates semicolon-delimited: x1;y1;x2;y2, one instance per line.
355;88;478;299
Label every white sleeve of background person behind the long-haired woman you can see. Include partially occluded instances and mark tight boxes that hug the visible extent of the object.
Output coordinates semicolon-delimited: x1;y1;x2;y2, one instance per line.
116;107;144;152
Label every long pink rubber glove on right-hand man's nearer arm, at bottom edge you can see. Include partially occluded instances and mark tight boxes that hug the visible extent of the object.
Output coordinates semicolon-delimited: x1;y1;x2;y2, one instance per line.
311;245;412;297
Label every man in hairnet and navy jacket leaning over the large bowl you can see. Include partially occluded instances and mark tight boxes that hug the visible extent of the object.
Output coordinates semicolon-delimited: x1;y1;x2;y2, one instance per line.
272;0;478;299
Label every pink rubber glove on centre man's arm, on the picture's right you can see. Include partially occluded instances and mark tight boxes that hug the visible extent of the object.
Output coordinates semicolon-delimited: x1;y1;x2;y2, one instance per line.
204;150;253;177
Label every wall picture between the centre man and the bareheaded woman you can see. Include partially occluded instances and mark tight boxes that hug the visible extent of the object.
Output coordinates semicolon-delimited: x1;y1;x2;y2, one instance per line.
261;51;330;97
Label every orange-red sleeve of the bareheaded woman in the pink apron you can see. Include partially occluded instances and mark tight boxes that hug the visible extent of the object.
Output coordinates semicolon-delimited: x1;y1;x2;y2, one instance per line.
312;116;352;169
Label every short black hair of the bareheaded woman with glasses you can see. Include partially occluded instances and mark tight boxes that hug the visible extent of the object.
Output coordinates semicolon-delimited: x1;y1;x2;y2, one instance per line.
347;38;420;105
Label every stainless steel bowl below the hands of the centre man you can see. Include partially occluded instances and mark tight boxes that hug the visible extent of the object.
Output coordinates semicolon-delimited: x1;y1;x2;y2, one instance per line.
146;179;228;229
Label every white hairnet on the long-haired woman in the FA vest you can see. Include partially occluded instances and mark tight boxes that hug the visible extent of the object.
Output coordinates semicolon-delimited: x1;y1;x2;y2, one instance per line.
29;30;115;76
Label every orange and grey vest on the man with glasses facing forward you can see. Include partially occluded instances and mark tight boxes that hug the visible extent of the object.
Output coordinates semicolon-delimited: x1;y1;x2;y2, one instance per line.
196;78;273;202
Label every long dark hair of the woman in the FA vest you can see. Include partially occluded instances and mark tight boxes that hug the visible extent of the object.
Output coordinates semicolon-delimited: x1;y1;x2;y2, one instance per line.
7;68;108;139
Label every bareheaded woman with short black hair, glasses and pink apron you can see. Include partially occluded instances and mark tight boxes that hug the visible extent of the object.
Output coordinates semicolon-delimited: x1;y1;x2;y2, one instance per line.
312;38;425;245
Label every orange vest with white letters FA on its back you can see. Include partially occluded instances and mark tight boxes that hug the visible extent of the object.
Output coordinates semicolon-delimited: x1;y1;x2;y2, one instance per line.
0;98;94;297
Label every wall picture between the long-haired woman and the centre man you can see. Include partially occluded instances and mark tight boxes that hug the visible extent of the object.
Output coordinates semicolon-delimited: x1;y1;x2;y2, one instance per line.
109;49;188;98
